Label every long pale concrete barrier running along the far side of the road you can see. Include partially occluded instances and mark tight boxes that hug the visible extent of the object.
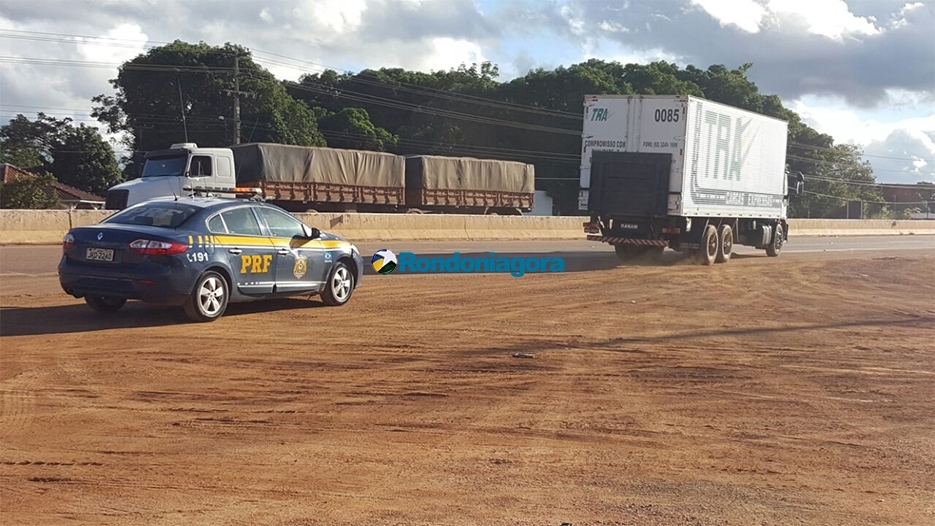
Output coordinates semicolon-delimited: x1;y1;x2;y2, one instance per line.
0;210;935;245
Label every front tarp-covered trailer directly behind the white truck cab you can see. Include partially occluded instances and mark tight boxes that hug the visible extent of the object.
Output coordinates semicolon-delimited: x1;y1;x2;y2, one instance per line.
230;143;406;211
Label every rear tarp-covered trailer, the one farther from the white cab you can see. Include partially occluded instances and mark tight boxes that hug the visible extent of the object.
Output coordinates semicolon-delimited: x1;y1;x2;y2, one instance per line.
405;155;536;215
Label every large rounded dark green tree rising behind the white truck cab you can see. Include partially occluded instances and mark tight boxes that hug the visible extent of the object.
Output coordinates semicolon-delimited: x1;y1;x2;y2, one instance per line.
92;40;325;172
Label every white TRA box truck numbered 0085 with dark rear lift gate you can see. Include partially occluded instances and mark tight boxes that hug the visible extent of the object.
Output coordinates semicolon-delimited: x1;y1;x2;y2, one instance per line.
578;95;804;265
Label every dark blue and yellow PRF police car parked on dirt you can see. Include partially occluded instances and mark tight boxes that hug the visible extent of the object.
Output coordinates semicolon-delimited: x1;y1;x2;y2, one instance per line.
58;197;364;322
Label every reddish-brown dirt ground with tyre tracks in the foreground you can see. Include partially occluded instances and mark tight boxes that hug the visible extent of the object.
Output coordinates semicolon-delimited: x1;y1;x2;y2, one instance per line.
0;252;935;526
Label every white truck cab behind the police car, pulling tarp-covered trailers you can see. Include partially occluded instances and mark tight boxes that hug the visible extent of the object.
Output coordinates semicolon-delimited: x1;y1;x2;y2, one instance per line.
104;143;236;210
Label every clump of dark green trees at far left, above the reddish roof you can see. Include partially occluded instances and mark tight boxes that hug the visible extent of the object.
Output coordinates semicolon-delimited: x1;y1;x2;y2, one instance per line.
0;113;123;195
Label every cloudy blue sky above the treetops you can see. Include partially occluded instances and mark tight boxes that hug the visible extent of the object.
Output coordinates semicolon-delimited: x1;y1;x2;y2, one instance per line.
0;0;935;183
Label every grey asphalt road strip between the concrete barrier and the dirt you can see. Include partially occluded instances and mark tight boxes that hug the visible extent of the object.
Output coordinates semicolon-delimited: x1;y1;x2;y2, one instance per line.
0;235;935;276
